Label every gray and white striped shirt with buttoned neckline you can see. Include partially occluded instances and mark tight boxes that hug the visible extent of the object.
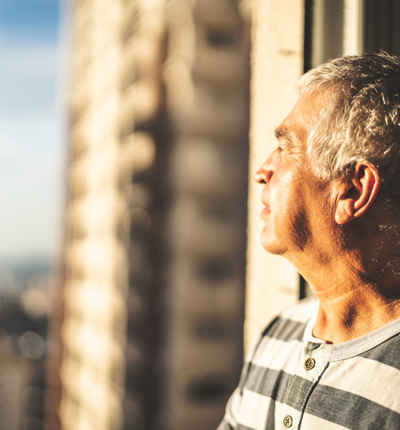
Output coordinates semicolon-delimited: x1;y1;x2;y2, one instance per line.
217;299;400;430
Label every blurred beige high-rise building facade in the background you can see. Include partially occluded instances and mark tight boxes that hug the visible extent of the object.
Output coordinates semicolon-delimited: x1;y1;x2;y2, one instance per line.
48;0;250;430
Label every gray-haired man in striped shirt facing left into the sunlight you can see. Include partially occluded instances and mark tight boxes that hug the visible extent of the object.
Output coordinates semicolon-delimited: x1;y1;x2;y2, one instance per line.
218;53;400;430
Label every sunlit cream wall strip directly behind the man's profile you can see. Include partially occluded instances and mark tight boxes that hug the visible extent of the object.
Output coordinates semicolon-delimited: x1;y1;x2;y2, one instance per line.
245;0;304;349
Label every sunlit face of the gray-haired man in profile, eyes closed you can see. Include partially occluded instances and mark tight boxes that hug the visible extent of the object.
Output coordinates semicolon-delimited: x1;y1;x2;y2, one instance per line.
255;94;328;257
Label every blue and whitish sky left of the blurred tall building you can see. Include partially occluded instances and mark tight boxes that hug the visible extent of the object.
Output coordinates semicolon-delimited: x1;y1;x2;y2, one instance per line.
0;0;65;258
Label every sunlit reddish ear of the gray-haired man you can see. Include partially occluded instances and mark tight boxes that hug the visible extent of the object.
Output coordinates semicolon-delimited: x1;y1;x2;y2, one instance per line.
335;162;381;225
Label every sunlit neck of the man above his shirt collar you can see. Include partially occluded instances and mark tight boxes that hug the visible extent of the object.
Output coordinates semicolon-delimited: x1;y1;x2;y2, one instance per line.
292;225;400;343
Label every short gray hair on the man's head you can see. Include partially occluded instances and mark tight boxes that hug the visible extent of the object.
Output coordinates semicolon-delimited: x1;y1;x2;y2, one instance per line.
298;52;400;226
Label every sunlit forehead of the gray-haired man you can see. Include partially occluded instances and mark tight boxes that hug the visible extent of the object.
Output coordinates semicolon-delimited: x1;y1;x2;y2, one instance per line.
275;92;325;145
